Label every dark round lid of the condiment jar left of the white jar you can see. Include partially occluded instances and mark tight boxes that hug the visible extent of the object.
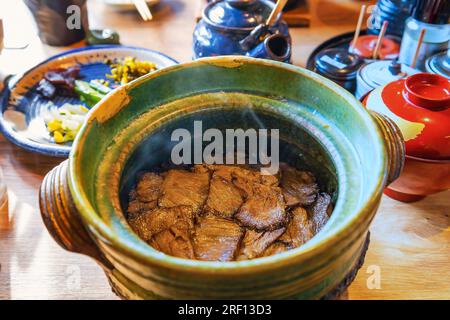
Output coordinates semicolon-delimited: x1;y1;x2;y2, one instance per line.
315;48;364;80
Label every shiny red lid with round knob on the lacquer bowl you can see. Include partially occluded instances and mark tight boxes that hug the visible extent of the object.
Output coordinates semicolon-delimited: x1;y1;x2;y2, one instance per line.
364;73;450;160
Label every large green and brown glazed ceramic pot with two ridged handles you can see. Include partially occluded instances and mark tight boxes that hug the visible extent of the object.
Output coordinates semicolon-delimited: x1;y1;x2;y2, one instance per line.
40;56;404;299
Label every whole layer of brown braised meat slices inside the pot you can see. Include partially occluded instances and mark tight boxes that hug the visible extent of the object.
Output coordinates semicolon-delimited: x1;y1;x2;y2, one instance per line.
126;164;332;261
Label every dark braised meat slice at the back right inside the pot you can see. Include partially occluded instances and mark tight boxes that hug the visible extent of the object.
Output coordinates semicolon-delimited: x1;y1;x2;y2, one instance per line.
281;164;319;206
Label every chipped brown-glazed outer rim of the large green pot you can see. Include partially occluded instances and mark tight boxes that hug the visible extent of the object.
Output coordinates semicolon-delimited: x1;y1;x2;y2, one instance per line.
68;56;387;275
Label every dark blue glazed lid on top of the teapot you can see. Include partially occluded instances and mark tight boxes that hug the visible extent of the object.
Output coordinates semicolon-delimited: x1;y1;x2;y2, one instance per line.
203;0;274;29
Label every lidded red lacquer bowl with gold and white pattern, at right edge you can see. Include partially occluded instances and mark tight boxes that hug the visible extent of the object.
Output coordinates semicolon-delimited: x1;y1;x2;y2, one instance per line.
363;73;450;202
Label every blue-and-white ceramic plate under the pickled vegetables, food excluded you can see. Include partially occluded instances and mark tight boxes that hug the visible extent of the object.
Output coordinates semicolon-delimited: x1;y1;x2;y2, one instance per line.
0;45;177;157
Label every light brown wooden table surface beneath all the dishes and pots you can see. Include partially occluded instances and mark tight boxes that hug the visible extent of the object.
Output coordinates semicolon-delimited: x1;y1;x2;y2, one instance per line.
0;0;450;299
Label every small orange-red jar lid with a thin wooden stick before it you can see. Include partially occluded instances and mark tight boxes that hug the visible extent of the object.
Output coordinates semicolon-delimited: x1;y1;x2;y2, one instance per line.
351;35;400;60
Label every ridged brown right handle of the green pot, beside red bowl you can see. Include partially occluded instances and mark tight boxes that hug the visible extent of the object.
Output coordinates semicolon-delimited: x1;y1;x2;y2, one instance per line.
369;110;405;186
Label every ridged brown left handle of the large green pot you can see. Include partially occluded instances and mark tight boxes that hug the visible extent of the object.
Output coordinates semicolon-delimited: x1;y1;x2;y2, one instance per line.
39;160;113;270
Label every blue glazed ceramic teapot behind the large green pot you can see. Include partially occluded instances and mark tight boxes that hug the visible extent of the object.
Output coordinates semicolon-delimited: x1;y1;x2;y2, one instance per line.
193;0;291;62
